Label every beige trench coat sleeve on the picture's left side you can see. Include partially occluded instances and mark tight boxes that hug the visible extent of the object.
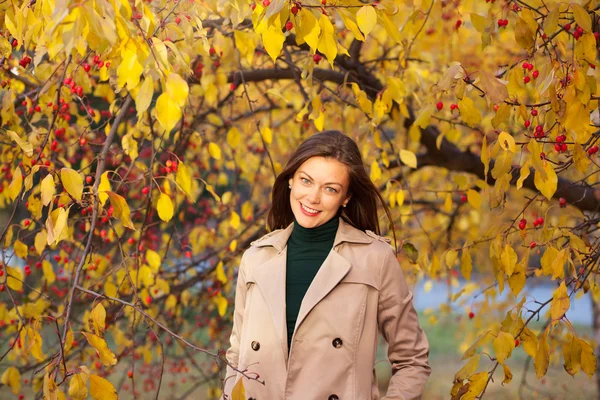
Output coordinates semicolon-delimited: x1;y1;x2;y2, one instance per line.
221;254;246;399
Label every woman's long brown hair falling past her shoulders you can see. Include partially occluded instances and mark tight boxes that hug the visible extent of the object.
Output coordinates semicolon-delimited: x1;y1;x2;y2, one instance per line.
267;130;396;241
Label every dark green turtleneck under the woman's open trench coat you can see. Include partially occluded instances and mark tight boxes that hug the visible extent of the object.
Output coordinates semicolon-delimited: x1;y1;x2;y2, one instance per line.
285;216;339;352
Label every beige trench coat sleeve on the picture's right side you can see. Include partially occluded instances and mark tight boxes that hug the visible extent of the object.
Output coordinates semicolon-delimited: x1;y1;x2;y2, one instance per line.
377;248;431;400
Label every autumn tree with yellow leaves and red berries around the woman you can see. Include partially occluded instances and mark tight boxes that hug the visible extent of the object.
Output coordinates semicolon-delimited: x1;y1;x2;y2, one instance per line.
0;0;600;398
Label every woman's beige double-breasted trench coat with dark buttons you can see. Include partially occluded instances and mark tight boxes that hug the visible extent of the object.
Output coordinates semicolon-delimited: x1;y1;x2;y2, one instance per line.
223;218;431;400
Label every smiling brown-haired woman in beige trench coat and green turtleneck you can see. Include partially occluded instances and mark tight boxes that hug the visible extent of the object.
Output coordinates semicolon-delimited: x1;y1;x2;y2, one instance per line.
224;131;431;400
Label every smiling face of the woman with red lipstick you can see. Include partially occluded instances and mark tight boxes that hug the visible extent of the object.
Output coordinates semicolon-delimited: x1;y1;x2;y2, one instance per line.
289;157;350;228
